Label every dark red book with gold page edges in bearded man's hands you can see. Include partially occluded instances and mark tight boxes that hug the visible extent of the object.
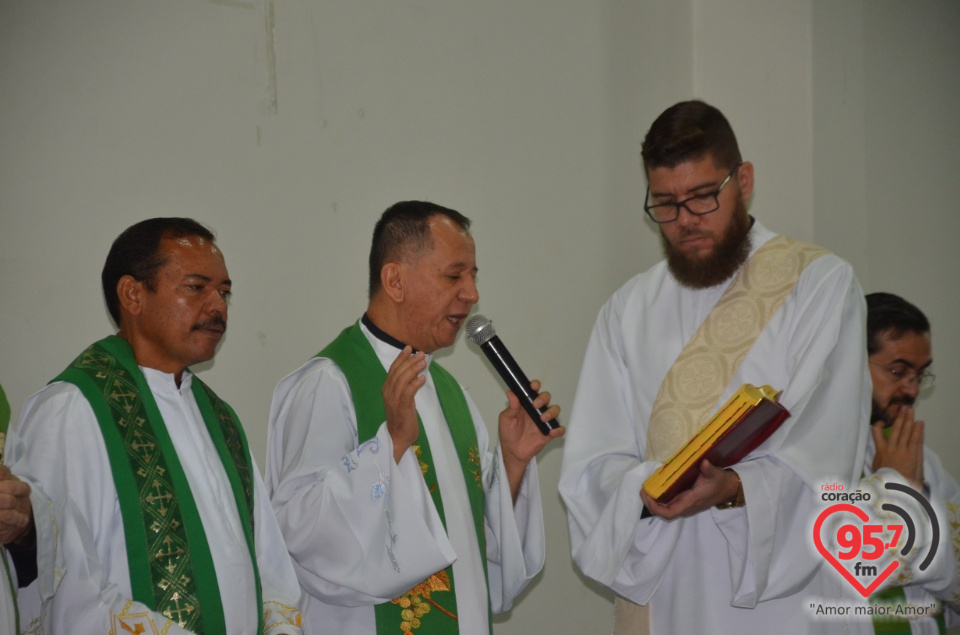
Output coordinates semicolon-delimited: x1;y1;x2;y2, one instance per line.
643;384;790;503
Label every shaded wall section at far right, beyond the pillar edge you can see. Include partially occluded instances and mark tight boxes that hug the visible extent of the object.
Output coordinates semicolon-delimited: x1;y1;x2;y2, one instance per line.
813;0;960;476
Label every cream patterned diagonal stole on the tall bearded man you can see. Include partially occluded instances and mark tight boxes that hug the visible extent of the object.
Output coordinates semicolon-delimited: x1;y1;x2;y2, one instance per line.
613;236;829;635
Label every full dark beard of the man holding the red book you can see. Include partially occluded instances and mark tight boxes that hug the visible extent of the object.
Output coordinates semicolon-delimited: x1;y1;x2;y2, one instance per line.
660;197;751;289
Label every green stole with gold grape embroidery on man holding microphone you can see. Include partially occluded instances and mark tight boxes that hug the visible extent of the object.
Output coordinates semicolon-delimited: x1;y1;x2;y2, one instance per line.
317;323;493;635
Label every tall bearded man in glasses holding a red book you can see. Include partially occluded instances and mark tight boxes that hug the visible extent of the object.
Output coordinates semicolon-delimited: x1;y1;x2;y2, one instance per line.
560;101;870;634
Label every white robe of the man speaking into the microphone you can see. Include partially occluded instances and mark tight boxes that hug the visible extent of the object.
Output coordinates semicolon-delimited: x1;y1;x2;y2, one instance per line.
265;324;544;635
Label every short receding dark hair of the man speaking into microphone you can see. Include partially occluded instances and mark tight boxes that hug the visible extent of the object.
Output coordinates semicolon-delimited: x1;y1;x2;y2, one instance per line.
369;201;470;299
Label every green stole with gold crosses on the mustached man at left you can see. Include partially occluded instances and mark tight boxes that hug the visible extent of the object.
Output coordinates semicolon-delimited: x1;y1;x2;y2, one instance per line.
53;336;263;635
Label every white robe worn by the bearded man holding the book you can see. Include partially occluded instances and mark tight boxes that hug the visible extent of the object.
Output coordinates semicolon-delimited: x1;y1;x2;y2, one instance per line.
560;222;871;635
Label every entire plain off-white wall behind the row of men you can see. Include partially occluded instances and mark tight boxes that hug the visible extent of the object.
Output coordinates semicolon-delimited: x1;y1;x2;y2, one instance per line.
0;0;960;633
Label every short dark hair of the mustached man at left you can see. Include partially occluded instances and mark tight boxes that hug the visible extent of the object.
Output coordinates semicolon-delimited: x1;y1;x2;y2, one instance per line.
100;218;214;326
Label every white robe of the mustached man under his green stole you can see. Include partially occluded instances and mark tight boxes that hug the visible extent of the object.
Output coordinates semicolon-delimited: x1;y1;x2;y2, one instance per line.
16;367;301;635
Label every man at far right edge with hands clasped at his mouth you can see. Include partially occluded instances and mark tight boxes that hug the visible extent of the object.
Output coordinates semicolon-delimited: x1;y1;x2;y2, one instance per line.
863;293;960;633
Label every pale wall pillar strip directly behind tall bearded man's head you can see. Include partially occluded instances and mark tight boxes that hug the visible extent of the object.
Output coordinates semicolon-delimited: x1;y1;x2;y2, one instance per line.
693;0;813;240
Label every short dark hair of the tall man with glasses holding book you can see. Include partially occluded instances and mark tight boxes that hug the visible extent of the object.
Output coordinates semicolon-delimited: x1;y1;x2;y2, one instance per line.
640;100;743;170
